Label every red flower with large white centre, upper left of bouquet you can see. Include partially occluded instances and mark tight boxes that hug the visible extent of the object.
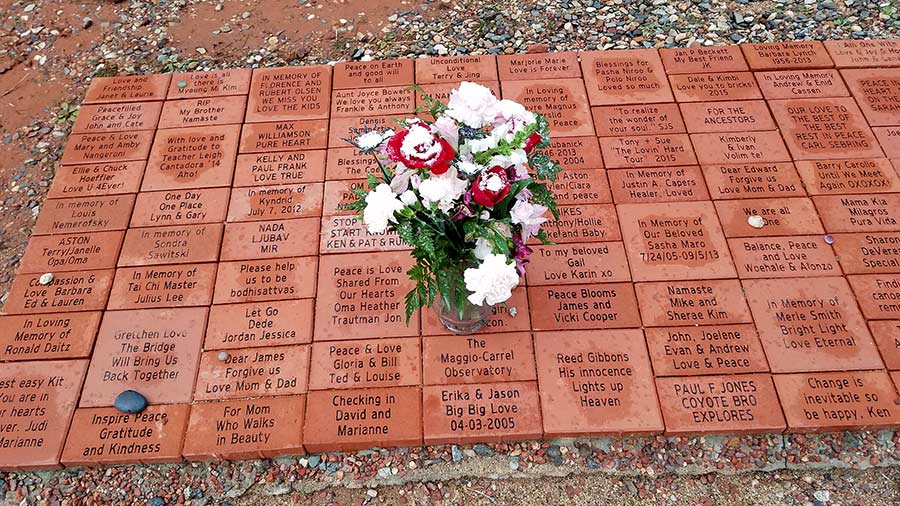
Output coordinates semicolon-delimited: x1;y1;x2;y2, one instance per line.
385;123;456;174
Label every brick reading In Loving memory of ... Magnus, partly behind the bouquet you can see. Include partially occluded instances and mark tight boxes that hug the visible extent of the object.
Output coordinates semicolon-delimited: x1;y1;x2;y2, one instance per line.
502;78;594;137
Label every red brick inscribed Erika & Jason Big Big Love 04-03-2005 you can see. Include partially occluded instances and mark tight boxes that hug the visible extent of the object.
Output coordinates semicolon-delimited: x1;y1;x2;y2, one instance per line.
422;381;543;445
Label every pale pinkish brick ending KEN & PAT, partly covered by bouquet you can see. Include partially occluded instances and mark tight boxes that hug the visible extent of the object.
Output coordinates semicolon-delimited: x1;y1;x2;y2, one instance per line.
319;216;412;254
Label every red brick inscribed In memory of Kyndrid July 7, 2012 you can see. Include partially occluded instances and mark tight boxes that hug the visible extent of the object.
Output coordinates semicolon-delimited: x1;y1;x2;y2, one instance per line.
228;183;324;222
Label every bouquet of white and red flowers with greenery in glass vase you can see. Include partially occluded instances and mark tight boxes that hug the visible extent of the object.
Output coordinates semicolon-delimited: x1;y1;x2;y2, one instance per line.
348;82;560;333
